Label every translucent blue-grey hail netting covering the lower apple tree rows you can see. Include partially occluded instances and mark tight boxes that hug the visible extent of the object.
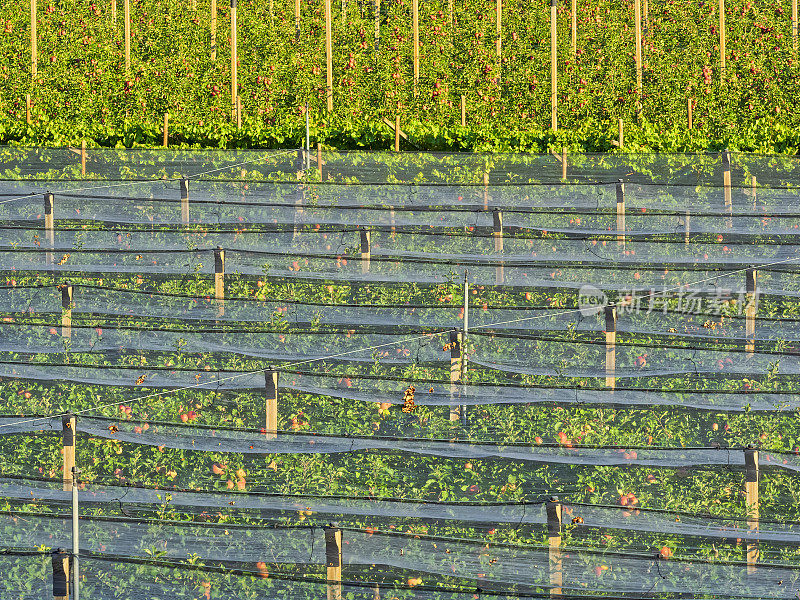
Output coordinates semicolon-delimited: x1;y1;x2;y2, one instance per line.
0;148;800;600
